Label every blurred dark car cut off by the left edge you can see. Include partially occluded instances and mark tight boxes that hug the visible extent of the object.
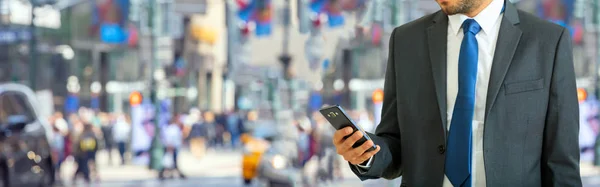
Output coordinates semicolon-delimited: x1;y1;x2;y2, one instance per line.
0;84;54;187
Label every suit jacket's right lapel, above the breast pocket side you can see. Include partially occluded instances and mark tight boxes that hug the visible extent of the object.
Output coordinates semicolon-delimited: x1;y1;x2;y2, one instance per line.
485;2;522;120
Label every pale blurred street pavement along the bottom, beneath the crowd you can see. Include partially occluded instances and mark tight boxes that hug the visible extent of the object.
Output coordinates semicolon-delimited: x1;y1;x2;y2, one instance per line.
58;151;400;187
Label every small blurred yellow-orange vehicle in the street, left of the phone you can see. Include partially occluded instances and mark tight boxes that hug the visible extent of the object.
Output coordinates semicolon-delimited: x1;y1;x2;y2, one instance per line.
241;122;276;185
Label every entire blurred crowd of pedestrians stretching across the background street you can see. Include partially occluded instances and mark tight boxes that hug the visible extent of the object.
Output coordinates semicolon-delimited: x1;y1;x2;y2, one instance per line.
49;108;375;183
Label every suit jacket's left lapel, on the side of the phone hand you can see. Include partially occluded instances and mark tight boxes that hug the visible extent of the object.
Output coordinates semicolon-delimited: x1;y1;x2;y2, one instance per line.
427;11;448;139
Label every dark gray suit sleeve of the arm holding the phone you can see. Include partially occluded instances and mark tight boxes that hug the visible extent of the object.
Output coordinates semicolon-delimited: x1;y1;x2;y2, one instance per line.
350;29;402;180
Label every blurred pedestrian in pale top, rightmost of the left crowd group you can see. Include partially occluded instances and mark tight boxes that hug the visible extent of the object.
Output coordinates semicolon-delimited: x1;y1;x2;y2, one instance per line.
112;115;131;165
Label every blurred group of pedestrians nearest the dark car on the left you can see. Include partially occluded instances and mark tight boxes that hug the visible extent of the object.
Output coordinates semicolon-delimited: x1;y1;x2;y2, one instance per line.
49;108;131;182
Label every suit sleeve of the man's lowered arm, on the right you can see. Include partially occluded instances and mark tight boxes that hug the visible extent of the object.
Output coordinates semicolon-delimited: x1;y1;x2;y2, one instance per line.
541;29;582;187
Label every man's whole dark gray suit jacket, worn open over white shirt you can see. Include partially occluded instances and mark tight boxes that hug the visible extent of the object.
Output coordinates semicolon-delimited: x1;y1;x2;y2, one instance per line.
352;3;581;187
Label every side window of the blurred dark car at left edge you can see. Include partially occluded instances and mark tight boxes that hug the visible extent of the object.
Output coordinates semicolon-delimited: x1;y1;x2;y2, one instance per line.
0;92;35;124
